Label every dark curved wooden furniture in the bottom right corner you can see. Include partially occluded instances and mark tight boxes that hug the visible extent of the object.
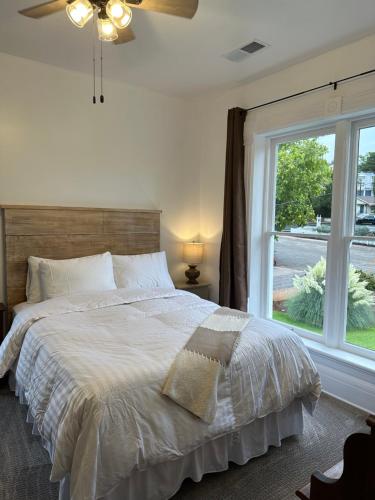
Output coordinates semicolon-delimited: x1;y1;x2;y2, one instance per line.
296;415;375;500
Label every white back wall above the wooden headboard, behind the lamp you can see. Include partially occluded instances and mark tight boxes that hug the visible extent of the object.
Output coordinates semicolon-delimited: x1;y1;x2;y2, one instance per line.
0;53;199;299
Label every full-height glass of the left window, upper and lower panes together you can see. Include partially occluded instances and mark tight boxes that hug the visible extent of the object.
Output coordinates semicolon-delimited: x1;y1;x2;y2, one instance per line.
272;131;335;335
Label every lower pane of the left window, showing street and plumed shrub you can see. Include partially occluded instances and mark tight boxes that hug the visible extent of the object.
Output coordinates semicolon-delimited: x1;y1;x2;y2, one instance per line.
272;236;327;334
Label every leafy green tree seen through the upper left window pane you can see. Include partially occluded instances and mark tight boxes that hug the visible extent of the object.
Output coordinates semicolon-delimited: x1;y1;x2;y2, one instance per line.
275;138;332;231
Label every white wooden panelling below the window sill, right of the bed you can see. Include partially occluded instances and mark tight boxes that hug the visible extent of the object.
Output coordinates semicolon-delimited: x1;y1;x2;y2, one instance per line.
310;351;375;414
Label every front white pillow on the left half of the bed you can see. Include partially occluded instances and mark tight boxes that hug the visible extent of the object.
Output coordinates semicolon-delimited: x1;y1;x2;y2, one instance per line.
39;252;116;300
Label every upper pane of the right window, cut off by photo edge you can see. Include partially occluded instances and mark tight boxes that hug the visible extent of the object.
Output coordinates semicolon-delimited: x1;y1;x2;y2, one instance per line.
354;127;375;232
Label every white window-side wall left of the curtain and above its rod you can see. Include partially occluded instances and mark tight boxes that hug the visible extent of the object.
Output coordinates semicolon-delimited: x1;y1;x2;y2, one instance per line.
189;36;375;299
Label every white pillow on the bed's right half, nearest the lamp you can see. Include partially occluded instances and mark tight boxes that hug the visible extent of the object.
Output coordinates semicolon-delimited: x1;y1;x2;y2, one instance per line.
112;252;174;289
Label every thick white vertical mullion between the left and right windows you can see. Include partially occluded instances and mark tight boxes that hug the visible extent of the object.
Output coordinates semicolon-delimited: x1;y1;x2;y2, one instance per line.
324;120;351;348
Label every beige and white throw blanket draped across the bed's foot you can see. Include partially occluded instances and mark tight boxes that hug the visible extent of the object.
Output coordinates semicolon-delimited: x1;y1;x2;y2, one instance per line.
162;307;250;423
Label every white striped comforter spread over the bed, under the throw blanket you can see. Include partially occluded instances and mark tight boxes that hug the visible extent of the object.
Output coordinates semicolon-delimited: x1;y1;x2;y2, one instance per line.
0;289;320;500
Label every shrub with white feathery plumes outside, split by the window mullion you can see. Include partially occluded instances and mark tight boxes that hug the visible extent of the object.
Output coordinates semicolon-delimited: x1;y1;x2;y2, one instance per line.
287;257;375;330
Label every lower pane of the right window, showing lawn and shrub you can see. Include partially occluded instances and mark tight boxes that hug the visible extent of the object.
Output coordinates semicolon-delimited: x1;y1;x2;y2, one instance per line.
346;240;375;350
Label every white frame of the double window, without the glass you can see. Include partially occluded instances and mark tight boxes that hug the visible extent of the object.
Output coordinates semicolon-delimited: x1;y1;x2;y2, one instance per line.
258;115;375;359
